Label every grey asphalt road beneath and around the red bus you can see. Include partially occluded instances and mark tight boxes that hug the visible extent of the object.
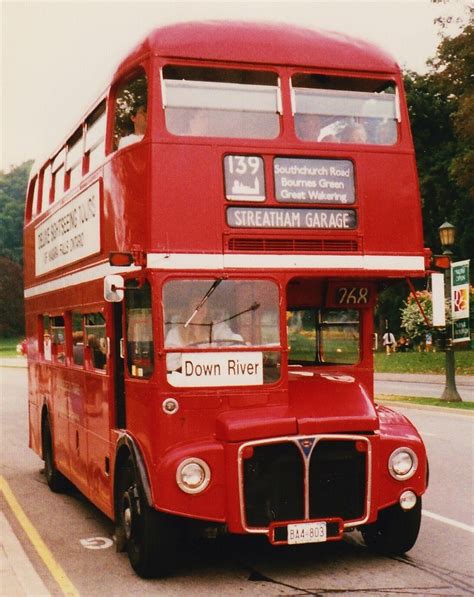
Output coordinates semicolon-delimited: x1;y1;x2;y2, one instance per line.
0;369;474;597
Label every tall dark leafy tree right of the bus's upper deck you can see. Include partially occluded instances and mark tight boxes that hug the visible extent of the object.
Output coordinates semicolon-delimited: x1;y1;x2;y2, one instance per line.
376;21;474;331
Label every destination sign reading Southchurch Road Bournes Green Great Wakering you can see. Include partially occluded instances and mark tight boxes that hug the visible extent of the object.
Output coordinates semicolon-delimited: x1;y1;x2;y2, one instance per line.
273;158;355;205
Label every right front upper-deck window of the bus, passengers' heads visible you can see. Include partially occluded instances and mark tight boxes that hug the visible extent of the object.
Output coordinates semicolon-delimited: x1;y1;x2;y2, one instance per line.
291;74;400;145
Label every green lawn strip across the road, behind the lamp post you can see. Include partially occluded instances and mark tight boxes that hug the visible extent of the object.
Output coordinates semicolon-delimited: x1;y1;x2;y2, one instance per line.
374;350;474;375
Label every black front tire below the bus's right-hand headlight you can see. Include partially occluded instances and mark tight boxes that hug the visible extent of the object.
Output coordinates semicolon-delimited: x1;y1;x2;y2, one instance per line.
361;497;421;555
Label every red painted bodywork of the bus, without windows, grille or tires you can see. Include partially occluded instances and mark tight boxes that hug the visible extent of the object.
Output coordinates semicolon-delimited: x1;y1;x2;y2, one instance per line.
25;23;427;533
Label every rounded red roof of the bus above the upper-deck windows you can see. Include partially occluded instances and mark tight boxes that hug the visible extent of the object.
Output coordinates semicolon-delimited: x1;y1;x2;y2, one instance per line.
116;21;400;75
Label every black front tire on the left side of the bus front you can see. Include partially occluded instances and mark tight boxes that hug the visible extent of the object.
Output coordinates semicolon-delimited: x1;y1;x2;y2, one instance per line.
118;458;178;578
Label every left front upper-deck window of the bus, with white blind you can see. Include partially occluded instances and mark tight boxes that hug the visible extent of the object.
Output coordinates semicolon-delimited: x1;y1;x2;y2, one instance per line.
163;65;281;139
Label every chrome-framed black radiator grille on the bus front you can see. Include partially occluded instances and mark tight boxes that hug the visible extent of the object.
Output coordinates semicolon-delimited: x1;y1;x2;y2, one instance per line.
240;436;370;530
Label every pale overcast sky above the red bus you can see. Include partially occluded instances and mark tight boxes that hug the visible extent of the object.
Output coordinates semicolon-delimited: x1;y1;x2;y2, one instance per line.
0;0;464;170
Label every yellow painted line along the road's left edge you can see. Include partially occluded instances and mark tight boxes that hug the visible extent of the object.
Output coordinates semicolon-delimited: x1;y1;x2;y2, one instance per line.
0;475;79;597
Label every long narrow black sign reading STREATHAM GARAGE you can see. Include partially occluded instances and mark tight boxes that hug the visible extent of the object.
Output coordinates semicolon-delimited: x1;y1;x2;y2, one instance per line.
227;207;357;230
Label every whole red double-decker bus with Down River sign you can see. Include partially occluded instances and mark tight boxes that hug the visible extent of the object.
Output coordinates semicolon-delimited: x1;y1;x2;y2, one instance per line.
24;22;427;577
